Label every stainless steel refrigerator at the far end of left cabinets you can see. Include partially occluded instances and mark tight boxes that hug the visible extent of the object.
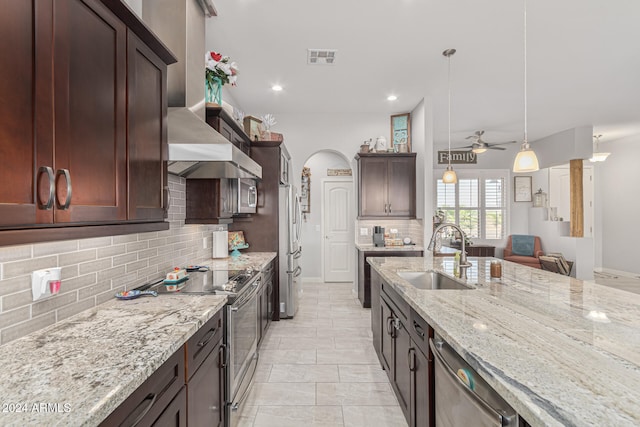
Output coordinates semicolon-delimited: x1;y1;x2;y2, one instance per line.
278;184;302;319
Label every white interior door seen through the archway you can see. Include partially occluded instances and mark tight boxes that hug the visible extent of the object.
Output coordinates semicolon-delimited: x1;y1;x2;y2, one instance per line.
322;181;355;282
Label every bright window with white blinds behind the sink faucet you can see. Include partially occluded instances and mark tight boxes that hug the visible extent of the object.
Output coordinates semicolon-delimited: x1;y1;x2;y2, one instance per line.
436;173;507;239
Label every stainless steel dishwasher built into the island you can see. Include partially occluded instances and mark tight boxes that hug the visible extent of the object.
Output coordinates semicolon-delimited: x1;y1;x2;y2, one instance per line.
429;334;518;427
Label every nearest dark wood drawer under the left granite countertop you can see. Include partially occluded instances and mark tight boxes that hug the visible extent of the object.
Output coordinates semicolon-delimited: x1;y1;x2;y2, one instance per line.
100;347;185;426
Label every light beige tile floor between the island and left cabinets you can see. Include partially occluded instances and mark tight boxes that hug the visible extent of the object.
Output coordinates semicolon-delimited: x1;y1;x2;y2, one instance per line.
240;283;407;427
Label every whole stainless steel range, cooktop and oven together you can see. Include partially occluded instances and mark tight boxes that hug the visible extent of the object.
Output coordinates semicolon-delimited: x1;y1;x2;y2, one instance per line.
151;270;262;426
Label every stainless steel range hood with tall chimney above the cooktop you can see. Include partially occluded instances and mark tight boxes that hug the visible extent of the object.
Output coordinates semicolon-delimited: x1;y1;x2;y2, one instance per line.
142;0;262;179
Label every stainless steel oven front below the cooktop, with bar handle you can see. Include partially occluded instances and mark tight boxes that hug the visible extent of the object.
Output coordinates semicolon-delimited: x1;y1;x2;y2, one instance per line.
225;274;261;426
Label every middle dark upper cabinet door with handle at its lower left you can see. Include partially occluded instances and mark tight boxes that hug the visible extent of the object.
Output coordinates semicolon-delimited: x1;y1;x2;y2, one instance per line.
53;0;127;226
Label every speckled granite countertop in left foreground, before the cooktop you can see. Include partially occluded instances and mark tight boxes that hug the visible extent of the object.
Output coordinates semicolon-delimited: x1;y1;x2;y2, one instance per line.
0;295;227;426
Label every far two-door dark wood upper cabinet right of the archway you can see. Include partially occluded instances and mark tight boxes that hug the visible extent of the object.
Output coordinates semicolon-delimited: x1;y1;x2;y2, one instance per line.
356;153;416;218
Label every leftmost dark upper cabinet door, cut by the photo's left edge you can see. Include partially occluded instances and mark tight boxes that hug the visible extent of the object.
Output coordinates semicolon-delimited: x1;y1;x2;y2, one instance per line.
0;0;49;226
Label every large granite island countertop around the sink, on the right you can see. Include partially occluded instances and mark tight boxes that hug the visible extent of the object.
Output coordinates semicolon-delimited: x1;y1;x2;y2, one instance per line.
368;256;640;426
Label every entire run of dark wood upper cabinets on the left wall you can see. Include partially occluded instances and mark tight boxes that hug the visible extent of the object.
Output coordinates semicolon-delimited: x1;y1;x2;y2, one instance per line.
0;0;175;245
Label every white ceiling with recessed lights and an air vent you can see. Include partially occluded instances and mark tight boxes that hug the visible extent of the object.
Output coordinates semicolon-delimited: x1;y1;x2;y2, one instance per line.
206;0;640;146
